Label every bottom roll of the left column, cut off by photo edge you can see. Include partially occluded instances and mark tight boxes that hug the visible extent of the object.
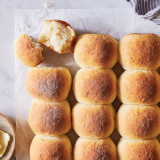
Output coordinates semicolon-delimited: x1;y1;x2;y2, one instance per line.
30;135;72;160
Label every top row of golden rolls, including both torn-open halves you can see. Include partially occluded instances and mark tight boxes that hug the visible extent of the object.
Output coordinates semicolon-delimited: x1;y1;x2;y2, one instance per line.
14;33;160;70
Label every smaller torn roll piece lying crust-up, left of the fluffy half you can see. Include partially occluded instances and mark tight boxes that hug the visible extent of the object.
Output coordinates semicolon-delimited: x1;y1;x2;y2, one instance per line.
14;34;43;67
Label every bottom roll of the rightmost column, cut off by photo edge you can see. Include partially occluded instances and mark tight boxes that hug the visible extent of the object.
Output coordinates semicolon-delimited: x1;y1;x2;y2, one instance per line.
117;138;160;160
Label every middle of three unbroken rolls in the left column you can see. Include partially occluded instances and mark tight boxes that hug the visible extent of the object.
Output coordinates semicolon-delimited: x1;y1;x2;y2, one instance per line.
28;101;71;136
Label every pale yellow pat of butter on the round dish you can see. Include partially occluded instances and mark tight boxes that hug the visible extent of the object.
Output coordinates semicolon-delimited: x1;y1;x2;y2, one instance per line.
0;130;10;157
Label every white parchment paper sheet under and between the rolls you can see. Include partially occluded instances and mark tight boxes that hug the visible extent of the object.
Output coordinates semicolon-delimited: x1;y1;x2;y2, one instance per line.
15;9;160;160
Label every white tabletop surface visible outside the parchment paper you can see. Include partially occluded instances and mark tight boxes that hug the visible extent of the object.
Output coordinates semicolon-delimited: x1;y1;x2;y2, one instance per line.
0;0;131;160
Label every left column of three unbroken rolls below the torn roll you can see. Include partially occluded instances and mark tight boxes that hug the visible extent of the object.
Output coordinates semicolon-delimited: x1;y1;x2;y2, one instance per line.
26;67;72;160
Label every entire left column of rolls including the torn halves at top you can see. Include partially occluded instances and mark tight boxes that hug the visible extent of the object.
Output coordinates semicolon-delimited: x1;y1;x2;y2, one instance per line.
14;20;76;160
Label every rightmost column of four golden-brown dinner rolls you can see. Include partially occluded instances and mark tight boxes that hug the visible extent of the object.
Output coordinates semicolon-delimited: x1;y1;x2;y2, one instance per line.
116;34;160;160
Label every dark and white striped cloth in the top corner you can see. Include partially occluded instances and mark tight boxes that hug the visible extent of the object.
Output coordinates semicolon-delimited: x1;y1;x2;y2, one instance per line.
127;0;160;25
